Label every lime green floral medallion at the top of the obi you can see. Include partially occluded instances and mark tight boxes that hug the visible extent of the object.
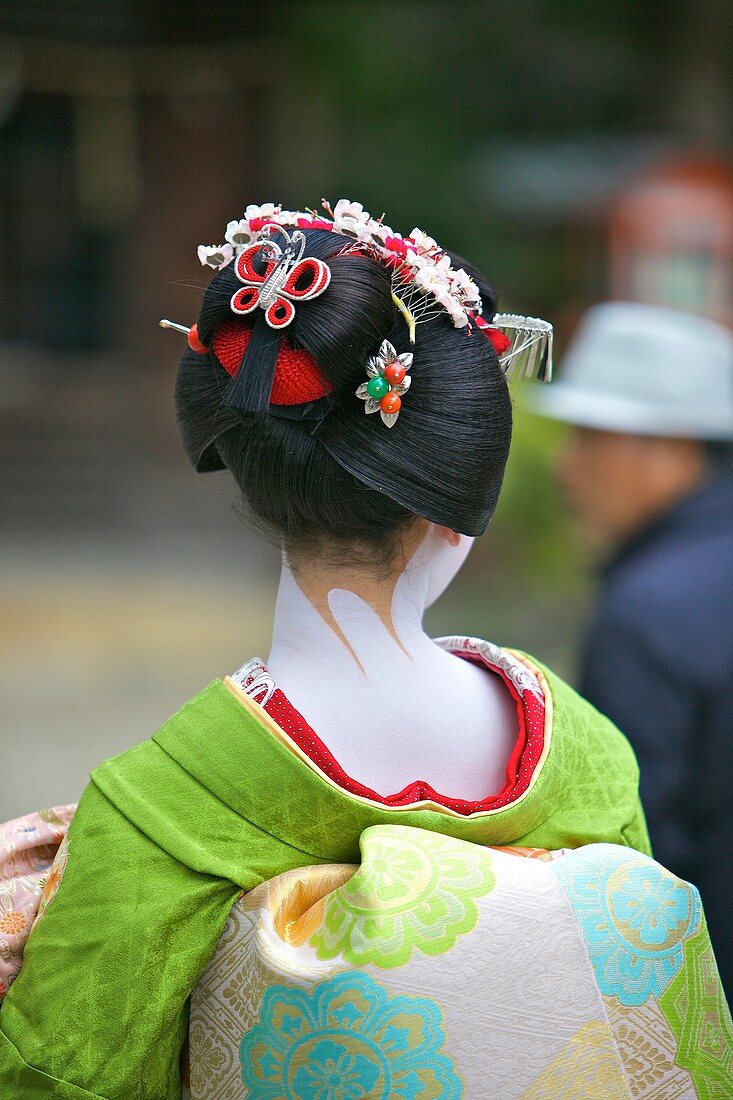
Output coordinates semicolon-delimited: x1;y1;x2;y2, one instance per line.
310;825;496;969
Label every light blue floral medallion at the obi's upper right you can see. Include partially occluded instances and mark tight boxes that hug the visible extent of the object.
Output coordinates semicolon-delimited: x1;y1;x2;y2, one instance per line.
549;845;701;1004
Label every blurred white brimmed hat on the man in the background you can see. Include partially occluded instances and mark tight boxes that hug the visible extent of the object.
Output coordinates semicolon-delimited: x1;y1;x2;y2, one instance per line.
532;301;733;440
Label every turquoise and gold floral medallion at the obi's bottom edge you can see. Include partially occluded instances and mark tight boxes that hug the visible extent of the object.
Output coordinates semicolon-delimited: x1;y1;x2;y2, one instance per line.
240;972;462;1100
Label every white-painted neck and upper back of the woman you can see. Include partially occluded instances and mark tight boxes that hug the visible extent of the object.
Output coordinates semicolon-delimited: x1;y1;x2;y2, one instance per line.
267;525;517;799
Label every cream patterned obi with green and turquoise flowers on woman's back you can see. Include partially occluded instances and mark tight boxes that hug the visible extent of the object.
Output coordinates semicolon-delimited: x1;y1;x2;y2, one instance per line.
183;825;733;1100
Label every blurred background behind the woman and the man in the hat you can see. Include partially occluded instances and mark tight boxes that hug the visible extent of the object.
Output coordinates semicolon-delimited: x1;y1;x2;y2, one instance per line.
0;0;733;820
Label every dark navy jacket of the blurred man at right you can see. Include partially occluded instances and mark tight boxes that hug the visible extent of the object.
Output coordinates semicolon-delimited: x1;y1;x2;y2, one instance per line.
581;473;733;992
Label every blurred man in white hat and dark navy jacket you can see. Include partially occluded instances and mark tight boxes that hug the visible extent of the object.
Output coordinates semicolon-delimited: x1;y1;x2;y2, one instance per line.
534;303;733;989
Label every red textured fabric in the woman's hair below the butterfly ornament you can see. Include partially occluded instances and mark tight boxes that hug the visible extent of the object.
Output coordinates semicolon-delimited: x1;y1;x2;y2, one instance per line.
211;319;333;405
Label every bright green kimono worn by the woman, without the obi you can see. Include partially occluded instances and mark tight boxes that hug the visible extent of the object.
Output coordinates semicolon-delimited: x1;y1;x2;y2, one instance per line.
0;661;649;1100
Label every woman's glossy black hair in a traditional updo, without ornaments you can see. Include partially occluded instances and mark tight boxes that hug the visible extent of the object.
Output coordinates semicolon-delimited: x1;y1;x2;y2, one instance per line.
176;230;512;561
